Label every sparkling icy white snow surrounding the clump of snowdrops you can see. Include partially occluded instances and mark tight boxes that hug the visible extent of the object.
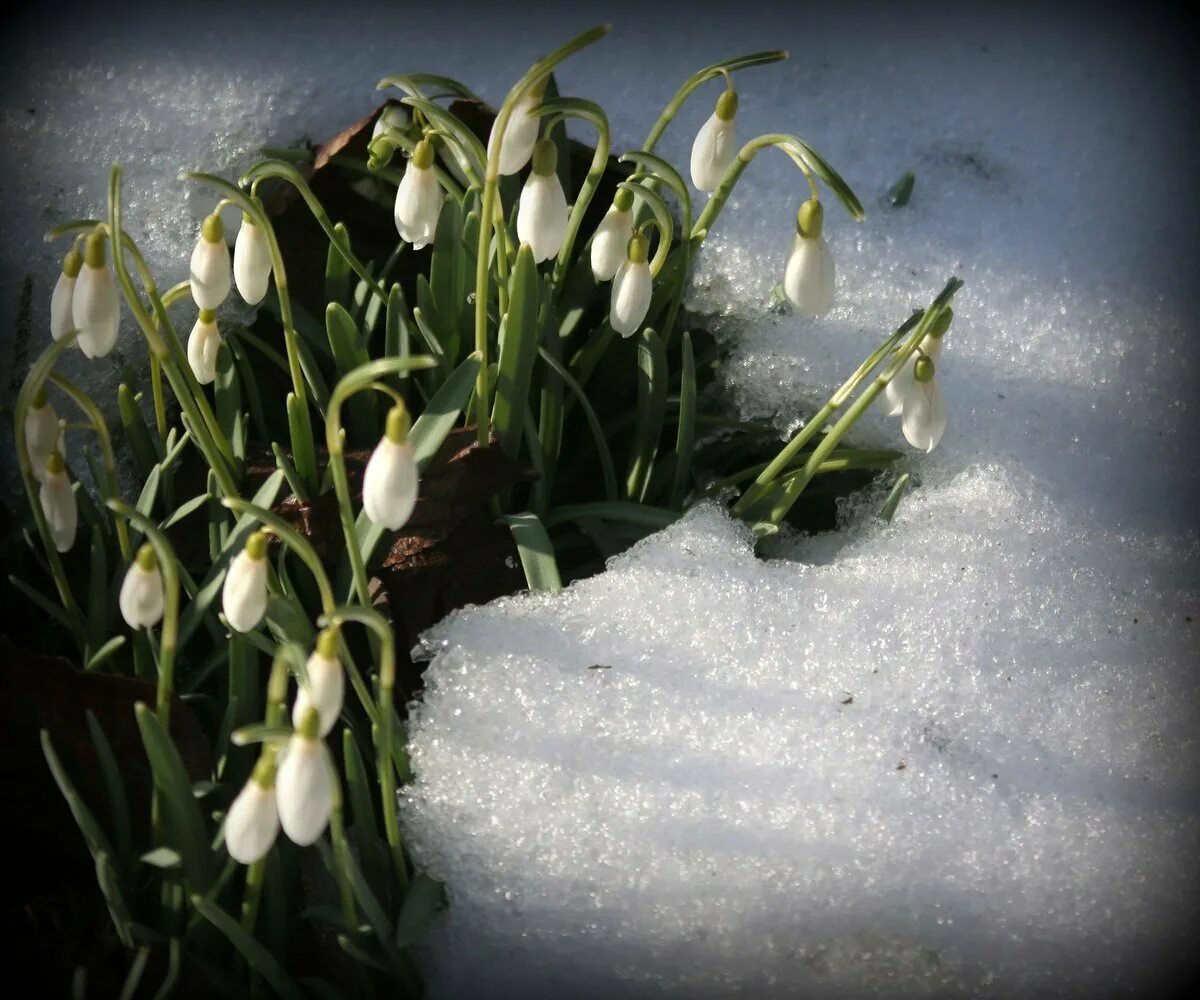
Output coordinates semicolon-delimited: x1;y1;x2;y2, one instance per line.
0;2;1200;998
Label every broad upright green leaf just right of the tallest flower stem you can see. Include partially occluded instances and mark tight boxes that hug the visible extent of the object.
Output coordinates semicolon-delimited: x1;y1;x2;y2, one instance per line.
492;244;538;459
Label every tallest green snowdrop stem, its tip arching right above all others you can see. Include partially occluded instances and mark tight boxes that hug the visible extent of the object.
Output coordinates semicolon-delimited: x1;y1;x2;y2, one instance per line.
475;24;608;448
